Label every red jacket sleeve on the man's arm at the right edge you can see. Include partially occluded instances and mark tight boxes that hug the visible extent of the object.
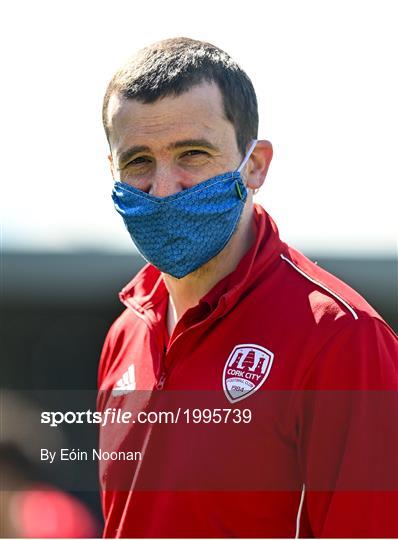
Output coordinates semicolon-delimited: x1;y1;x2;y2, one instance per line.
297;317;398;538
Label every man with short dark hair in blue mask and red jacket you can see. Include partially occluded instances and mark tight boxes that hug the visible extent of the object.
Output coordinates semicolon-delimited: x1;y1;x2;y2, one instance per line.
98;38;398;537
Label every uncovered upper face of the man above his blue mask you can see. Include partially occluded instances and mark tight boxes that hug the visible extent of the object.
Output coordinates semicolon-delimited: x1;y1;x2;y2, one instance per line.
108;82;242;197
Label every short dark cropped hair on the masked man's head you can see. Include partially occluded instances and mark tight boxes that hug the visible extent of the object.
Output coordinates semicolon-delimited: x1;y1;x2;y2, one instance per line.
102;37;258;155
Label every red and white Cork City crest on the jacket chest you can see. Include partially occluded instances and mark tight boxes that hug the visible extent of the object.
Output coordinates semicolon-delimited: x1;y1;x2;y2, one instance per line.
223;343;274;403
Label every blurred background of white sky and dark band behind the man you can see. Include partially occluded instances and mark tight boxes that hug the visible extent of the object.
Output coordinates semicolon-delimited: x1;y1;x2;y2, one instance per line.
0;0;398;537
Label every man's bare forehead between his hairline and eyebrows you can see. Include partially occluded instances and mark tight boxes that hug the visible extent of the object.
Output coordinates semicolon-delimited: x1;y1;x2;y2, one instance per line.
108;82;235;151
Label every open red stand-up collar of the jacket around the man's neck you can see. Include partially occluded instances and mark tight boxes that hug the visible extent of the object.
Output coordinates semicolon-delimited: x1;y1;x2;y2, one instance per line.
119;204;286;314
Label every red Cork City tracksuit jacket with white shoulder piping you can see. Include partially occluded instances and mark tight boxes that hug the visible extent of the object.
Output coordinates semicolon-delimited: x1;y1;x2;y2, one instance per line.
98;205;398;537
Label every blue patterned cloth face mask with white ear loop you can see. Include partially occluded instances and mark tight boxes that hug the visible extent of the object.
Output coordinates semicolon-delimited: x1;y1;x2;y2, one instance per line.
112;141;257;278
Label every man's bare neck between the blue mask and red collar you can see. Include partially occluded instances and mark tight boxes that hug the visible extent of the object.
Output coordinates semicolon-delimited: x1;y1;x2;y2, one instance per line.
163;200;255;334
